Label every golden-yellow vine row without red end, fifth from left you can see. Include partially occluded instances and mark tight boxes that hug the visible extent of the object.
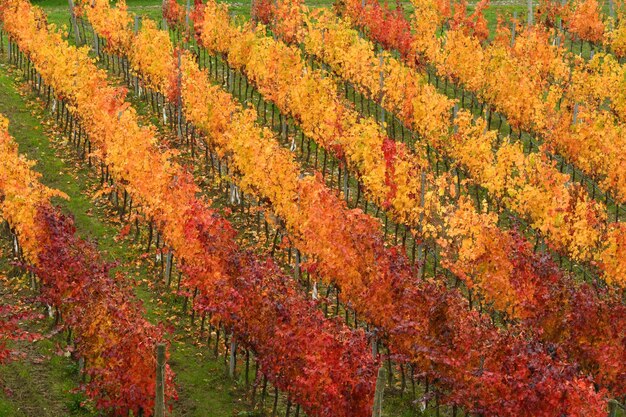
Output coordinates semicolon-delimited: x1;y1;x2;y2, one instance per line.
270;6;621;283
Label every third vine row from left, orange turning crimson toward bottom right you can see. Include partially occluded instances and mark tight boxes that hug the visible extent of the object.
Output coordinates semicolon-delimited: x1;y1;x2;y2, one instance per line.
79;3;620;415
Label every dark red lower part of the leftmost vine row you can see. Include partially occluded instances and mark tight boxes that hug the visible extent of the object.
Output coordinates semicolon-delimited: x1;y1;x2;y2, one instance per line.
33;207;176;416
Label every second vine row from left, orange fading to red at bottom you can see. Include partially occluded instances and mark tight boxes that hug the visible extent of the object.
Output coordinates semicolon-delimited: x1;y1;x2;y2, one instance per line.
0;0;380;417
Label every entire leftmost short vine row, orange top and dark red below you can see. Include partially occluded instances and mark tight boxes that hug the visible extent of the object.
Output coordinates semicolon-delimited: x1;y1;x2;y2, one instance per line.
0;116;176;416
